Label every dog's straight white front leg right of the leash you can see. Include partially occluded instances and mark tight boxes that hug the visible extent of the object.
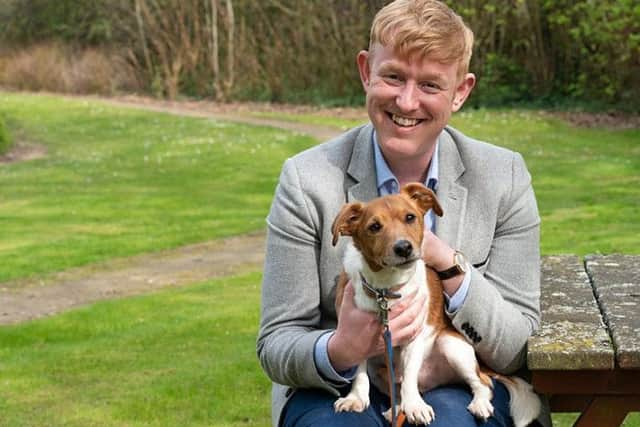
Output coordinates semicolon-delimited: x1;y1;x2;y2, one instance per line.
400;328;435;425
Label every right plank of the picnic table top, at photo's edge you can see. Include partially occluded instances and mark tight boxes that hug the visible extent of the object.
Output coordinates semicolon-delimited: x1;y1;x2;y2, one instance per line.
586;255;640;369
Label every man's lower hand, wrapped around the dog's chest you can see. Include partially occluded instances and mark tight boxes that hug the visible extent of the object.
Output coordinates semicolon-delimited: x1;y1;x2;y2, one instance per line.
328;282;427;372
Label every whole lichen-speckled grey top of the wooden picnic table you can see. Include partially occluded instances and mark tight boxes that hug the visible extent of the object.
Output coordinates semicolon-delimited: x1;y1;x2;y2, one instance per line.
527;255;640;370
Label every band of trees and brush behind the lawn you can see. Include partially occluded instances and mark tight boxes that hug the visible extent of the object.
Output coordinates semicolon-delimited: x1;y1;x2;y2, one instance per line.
0;0;640;112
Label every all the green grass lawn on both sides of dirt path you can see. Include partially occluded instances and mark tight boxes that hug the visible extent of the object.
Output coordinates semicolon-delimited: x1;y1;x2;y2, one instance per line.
0;93;640;427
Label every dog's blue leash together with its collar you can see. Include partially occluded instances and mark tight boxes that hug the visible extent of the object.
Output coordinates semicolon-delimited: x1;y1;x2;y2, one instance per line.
360;273;404;427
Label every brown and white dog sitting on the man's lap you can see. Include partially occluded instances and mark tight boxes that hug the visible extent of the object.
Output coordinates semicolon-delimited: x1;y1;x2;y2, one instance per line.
332;183;540;427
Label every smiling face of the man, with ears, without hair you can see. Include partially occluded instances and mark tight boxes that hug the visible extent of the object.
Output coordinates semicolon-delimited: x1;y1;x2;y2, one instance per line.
358;44;475;160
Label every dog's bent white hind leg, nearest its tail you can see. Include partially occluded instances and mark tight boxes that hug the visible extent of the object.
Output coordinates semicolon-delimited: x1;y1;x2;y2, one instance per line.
438;335;493;420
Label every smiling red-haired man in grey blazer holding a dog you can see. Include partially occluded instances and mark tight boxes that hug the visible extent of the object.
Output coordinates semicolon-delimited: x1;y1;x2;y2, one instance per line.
257;0;549;426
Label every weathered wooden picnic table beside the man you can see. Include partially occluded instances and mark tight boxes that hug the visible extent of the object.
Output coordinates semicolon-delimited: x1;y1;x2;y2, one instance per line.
527;255;640;427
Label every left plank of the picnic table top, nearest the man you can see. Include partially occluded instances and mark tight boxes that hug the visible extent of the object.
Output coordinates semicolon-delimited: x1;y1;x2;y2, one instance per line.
527;255;614;370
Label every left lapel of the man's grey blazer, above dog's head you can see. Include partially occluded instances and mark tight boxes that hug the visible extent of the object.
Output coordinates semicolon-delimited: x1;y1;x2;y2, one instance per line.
345;124;378;202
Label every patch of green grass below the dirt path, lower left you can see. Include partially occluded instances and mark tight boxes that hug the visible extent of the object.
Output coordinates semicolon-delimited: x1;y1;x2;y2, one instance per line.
0;273;270;427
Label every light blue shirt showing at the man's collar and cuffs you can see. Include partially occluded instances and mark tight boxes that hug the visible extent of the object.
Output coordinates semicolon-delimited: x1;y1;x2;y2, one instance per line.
314;131;471;385
